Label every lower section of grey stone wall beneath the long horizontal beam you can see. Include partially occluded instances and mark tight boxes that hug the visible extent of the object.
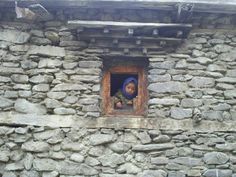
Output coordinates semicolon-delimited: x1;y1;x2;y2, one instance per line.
0;126;236;177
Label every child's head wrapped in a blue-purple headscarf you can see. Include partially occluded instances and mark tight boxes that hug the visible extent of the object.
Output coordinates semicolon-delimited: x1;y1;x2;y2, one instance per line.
122;77;138;99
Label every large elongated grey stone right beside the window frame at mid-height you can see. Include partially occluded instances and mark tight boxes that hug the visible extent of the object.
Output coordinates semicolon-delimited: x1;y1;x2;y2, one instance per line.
148;81;187;93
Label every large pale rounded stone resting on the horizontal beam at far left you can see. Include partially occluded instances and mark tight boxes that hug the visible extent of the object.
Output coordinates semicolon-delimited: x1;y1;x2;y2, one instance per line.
14;99;47;114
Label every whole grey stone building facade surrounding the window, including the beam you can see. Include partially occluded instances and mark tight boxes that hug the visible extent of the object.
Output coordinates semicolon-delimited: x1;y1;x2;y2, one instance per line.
0;1;236;177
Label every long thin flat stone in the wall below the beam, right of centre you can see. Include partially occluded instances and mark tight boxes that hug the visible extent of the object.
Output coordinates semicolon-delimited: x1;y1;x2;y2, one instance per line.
132;143;174;152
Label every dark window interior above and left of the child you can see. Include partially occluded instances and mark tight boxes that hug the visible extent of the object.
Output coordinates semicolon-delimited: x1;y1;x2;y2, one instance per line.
110;74;138;96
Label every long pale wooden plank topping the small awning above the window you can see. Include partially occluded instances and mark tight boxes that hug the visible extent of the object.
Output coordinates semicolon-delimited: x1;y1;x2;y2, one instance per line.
67;20;192;29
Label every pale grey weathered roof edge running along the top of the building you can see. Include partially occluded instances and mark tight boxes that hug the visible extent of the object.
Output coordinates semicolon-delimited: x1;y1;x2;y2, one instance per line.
0;0;236;14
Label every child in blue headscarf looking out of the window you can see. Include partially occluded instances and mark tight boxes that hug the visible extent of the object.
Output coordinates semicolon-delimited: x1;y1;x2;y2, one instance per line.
114;77;138;109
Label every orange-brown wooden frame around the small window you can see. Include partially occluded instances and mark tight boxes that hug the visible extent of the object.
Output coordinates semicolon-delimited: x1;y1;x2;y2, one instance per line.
102;66;147;116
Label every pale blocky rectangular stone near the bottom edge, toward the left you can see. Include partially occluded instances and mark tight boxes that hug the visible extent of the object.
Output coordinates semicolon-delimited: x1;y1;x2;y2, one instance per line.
33;158;58;171
